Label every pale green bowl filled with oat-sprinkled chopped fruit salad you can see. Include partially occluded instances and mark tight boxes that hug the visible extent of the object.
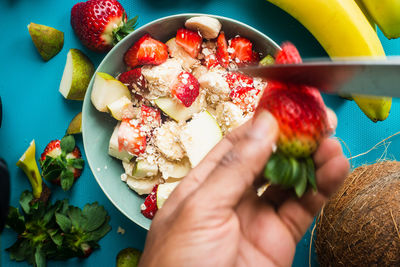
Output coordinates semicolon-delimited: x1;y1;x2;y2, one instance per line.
83;14;279;228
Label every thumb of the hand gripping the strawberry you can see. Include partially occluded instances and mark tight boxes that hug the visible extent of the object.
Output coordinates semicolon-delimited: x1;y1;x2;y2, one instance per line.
193;111;278;207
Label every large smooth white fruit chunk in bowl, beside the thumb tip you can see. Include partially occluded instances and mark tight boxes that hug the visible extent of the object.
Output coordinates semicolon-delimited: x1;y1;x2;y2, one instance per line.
180;111;222;168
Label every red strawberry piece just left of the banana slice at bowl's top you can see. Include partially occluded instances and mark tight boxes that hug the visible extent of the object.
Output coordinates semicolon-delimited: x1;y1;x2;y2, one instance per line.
175;28;203;58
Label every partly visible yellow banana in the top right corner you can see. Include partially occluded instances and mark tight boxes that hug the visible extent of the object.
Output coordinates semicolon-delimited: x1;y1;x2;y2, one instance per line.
358;0;400;39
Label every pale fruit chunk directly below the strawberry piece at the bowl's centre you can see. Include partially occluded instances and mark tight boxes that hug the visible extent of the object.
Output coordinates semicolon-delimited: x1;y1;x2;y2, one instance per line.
154;97;203;122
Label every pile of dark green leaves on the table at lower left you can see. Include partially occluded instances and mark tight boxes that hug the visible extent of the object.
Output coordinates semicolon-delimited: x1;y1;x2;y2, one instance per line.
6;191;111;267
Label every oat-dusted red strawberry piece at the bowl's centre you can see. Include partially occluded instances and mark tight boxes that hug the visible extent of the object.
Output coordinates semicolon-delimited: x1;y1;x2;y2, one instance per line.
171;71;200;107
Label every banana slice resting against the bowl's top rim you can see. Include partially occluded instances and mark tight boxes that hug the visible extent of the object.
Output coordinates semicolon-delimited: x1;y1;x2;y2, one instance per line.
185;16;222;40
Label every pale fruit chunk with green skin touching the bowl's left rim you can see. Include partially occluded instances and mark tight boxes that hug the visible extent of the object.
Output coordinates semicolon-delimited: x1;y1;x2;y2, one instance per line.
91;72;131;112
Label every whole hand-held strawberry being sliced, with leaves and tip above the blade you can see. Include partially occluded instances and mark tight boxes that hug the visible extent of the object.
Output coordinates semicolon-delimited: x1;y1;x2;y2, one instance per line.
258;43;329;197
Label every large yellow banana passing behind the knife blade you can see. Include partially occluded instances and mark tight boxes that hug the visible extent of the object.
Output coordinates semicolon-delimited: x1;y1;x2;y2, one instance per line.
268;0;392;122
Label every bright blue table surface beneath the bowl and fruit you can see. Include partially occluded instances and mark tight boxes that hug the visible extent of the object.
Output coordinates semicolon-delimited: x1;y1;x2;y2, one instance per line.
0;0;400;267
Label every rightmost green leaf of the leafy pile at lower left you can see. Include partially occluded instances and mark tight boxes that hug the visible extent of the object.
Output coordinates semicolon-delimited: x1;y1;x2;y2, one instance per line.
80;202;107;232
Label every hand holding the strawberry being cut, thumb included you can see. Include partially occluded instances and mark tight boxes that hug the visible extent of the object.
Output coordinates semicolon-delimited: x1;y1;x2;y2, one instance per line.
140;111;349;266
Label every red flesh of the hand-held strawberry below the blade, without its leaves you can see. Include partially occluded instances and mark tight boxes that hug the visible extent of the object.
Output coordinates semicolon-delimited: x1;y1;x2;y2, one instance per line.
259;85;328;157
